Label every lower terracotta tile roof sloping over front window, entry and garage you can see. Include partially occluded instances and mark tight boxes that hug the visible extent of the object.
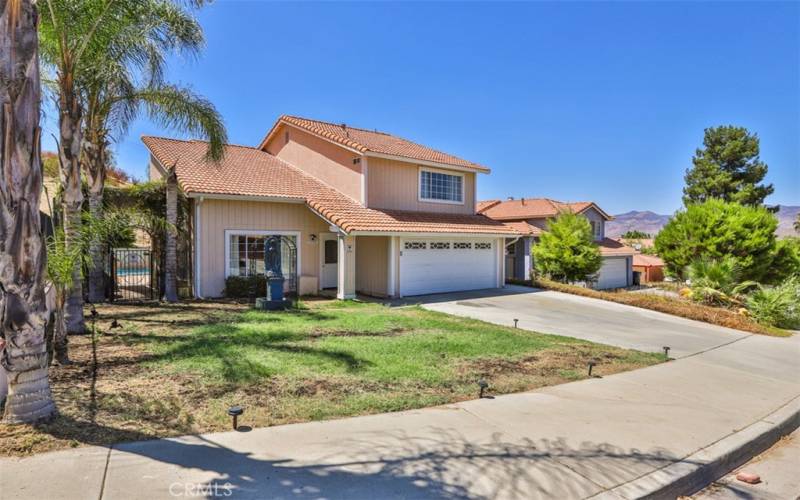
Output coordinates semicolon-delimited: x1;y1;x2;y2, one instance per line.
142;136;516;236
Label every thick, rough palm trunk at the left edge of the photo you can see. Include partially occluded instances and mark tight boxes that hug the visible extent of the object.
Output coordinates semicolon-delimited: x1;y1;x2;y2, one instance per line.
0;0;56;423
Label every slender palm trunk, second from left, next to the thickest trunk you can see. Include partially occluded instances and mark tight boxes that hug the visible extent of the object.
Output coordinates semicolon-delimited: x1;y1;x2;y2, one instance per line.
58;79;86;333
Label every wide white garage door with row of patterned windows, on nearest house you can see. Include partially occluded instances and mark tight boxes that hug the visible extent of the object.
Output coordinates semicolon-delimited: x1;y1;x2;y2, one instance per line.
400;238;497;296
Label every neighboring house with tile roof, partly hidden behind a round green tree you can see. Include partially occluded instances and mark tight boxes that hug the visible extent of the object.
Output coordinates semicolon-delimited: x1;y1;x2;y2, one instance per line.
478;198;636;289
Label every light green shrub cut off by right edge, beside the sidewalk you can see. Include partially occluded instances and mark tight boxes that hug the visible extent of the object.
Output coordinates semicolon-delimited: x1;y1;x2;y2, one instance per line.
747;276;800;330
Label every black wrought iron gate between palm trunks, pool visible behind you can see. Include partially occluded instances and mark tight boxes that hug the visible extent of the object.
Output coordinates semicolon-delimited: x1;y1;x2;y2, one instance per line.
109;248;161;302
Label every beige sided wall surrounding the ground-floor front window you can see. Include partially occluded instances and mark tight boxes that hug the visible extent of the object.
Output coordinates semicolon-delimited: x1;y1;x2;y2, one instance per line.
195;198;328;297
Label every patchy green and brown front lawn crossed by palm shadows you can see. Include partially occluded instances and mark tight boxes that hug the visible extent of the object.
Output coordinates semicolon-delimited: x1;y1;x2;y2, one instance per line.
0;300;662;454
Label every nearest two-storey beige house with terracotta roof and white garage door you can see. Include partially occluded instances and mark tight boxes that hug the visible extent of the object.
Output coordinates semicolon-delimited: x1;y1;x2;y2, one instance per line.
142;116;515;298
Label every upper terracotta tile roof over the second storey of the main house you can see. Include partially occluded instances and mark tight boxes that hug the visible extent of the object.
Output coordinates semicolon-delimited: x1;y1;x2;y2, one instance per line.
259;115;489;173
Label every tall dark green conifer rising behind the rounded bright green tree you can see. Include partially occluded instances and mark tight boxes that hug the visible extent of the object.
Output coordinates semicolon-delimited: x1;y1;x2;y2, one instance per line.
683;125;775;207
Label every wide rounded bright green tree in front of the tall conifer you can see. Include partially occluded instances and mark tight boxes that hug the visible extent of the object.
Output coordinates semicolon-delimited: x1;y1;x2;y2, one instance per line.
655;199;778;281
